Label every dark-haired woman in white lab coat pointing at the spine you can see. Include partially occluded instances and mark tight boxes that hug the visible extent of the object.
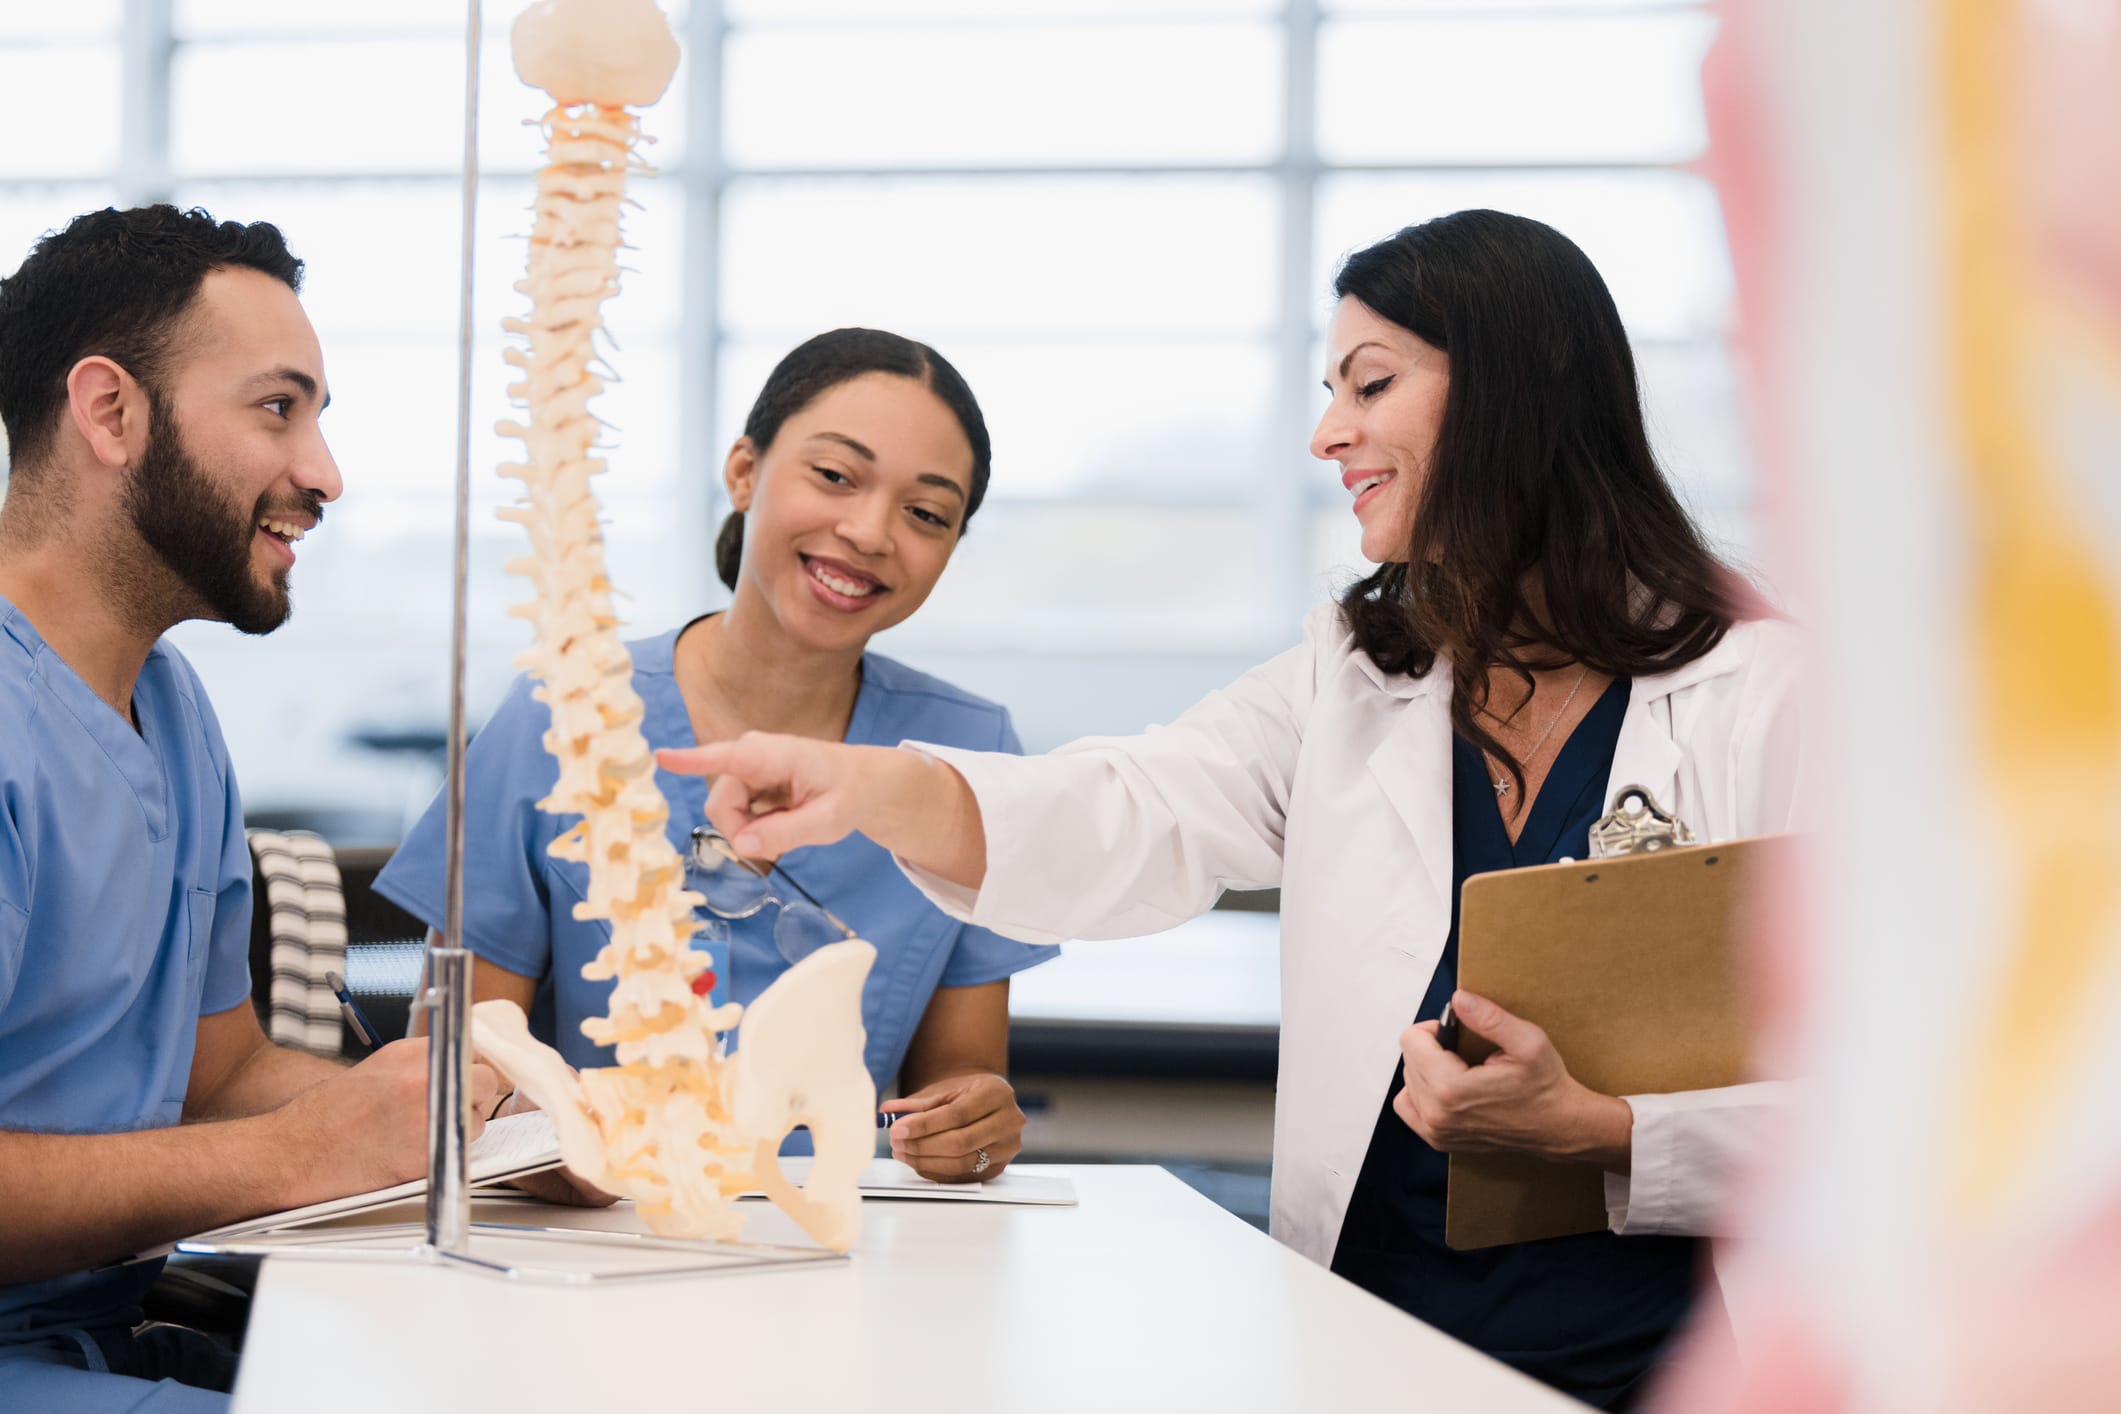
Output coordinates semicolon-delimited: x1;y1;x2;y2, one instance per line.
664;212;1801;1408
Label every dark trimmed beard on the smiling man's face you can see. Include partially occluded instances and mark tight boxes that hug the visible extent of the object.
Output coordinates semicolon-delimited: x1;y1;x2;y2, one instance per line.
125;394;322;634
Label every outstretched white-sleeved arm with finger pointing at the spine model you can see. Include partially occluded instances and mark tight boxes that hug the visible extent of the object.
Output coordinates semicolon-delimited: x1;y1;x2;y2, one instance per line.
660;606;1347;943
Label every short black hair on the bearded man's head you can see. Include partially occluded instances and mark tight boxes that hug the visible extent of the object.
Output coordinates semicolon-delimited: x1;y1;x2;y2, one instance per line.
0;206;301;475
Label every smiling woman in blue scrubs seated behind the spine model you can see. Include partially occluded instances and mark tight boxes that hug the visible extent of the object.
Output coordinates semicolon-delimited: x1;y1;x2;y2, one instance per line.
375;329;1056;1181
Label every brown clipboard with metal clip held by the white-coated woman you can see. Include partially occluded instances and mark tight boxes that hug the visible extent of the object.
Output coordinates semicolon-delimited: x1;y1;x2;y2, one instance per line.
1444;786;1794;1251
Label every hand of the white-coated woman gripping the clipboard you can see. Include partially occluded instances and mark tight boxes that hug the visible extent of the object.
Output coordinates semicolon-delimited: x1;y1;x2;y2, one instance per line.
1391;990;1635;1172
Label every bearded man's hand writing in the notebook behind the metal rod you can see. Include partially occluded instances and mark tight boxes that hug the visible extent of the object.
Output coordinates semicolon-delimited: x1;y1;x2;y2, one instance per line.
276;1037;501;1206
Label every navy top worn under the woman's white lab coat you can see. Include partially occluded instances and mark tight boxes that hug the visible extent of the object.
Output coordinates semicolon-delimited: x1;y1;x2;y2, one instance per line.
1332;678;1703;1408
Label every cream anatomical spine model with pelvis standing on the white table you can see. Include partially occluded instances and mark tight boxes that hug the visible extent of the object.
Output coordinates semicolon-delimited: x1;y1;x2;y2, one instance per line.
473;0;876;1251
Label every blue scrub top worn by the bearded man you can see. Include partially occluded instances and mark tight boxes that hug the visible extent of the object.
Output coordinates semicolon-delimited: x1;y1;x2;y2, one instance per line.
0;600;250;1339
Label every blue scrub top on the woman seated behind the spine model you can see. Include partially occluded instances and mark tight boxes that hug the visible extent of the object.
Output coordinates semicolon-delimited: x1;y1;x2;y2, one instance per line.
375;630;1058;1102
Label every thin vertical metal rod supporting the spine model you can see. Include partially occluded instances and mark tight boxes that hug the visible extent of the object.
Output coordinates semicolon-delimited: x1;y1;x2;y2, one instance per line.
422;0;484;1253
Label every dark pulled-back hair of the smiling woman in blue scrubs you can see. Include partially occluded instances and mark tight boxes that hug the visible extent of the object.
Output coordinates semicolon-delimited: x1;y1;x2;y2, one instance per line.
715;329;995;589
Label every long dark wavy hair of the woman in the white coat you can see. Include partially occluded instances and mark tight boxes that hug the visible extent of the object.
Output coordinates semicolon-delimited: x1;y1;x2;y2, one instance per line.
1332;210;1765;791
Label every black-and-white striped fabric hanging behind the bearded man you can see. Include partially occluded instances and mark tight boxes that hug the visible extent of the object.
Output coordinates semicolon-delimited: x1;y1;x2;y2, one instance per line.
248;829;346;1058
